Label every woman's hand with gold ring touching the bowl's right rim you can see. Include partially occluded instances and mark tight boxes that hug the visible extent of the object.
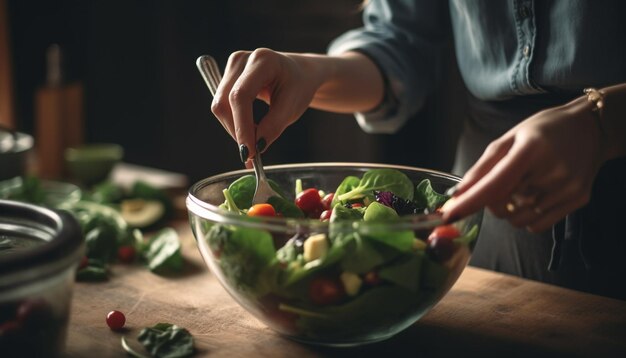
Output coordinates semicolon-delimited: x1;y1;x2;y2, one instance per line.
444;97;605;232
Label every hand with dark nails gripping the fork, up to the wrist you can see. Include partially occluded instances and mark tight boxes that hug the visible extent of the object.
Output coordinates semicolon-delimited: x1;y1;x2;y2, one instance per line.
211;49;322;162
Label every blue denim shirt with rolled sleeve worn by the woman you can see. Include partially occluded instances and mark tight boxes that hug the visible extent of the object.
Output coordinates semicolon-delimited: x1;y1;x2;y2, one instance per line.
329;0;626;133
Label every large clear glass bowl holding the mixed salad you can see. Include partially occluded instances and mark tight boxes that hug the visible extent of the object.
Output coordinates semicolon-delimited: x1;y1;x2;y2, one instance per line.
187;163;482;346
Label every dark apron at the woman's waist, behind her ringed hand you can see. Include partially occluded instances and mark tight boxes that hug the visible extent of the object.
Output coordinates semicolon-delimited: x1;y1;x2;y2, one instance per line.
453;94;626;299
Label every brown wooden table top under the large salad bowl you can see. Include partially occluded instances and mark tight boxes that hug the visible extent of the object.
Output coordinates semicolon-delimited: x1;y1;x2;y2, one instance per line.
66;222;626;358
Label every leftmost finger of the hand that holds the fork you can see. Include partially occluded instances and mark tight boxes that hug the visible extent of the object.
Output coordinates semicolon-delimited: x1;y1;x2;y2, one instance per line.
211;51;249;141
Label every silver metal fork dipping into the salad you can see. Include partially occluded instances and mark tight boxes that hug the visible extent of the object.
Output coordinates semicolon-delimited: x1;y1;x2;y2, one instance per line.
196;55;280;205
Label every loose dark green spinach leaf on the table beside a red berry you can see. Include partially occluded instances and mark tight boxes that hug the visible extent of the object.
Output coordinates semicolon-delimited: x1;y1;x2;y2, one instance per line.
137;323;195;358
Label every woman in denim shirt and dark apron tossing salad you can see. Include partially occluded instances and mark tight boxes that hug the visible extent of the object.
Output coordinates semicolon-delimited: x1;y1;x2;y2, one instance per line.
212;0;626;299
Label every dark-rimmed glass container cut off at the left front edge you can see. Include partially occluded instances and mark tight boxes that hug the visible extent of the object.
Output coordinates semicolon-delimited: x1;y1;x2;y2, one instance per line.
0;200;84;357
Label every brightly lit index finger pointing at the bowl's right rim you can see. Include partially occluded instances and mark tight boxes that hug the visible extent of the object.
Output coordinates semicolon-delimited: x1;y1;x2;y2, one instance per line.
444;138;533;219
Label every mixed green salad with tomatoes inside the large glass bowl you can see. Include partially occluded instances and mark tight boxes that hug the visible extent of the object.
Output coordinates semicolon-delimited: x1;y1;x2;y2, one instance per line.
192;168;478;344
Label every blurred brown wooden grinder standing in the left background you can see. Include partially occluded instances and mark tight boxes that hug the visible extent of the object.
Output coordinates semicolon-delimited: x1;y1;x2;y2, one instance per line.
35;44;83;179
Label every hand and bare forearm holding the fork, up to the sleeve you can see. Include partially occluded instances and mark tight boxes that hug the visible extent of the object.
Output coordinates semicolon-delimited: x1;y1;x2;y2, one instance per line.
211;48;383;162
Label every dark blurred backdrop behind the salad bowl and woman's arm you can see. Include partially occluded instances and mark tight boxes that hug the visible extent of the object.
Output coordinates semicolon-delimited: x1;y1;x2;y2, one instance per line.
8;0;464;181
